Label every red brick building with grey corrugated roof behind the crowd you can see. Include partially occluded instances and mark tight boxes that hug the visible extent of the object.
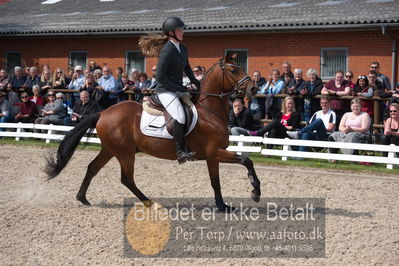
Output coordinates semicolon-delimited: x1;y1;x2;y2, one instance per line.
0;0;399;84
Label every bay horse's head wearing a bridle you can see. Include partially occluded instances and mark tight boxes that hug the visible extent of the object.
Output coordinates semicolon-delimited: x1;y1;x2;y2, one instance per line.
219;53;258;99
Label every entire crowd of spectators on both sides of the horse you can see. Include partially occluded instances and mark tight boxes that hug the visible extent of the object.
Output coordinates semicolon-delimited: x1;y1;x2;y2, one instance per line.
0;61;399;160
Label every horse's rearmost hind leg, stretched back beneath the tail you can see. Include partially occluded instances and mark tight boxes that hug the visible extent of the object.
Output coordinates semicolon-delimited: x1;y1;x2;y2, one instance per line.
76;149;113;205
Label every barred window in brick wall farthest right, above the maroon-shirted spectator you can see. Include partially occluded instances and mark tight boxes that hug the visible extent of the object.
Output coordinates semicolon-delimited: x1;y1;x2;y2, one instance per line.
320;48;348;79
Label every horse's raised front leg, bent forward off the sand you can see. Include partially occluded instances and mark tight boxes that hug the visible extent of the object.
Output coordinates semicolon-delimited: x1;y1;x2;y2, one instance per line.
216;149;261;202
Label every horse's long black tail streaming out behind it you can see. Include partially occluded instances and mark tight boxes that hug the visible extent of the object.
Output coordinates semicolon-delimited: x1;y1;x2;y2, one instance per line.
45;113;101;179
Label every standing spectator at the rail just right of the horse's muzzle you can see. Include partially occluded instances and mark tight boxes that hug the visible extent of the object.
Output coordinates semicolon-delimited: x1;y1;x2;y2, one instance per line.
249;70;266;124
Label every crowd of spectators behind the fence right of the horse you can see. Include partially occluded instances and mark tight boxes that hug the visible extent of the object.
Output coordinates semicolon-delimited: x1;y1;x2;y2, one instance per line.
229;62;399;159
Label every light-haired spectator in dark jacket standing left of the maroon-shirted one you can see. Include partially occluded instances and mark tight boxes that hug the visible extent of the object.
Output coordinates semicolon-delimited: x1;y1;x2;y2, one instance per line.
302;68;324;122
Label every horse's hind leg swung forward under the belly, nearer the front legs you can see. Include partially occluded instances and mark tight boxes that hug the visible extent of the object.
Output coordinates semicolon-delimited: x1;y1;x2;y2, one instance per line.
118;152;149;202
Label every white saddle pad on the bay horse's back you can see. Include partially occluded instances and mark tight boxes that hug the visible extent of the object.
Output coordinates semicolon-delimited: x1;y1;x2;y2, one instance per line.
140;105;198;139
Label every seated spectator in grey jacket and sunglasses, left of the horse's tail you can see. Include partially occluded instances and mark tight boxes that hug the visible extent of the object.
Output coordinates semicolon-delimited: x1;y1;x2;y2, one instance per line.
35;90;65;125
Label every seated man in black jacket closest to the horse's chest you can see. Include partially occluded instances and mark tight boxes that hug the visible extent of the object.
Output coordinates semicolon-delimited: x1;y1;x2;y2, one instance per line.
228;98;255;136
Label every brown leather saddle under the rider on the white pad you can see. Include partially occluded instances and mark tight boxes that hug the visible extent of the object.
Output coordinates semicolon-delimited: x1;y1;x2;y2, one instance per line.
143;94;193;136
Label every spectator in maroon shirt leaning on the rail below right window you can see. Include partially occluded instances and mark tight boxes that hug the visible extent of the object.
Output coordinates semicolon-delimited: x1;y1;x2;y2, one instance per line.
321;71;351;123
